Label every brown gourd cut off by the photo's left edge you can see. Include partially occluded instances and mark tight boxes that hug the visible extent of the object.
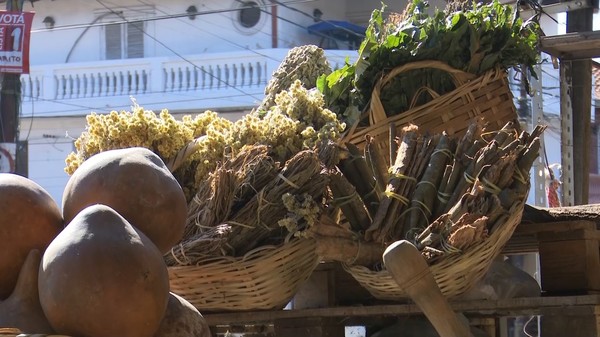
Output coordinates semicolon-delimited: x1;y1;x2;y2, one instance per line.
0;173;63;300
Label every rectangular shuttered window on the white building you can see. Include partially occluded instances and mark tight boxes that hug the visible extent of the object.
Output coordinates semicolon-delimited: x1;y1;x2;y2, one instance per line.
104;22;144;60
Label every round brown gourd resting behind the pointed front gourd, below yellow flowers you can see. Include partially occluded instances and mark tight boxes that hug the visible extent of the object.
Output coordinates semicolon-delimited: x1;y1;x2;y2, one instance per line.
63;147;187;253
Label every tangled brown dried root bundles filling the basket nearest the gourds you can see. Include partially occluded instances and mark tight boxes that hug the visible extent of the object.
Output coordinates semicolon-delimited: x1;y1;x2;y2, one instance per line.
165;145;329;265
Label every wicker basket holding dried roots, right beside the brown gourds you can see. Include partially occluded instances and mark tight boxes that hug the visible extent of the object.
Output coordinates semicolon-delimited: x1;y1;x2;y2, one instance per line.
169;239;319;312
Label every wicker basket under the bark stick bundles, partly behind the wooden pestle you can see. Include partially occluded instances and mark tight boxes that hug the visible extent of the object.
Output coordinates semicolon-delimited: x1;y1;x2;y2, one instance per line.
344;200;525;300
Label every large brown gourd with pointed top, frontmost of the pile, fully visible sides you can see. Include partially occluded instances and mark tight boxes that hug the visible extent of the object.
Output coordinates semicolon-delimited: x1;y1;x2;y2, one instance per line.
38;205;169;337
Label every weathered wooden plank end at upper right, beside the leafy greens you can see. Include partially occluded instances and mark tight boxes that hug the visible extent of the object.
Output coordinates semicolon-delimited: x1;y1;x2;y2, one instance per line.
540;31;600;60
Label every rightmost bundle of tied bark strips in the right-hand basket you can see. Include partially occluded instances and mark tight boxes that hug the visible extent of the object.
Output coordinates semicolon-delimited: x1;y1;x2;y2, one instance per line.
414;124;544;262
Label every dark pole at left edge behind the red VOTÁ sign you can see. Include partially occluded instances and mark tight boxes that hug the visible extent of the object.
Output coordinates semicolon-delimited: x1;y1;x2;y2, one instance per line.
0;0;27;176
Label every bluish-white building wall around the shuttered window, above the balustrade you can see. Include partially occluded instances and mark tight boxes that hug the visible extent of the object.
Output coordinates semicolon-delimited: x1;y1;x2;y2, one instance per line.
24;0;282;65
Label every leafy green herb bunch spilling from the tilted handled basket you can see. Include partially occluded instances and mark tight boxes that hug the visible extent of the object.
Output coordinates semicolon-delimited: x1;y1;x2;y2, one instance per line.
317;0;541;125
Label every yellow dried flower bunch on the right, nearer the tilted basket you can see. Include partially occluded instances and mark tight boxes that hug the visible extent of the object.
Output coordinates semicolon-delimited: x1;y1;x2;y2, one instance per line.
182;80;345;186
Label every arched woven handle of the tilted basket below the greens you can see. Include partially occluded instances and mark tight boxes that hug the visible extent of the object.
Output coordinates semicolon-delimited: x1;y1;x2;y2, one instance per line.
369;60;477;125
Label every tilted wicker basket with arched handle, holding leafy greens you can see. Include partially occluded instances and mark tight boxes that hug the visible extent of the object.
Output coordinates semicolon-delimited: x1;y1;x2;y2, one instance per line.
345;61;517;165
